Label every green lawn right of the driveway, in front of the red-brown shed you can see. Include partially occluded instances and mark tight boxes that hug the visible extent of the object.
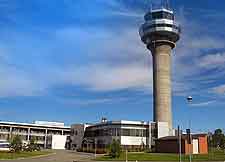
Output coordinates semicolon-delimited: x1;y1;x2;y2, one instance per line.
95;151;225;161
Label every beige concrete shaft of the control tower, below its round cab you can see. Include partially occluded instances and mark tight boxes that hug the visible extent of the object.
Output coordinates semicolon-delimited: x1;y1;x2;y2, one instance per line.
151;44;172;130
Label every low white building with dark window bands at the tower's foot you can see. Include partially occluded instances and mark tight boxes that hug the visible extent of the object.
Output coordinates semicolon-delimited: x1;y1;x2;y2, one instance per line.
71;120;171;149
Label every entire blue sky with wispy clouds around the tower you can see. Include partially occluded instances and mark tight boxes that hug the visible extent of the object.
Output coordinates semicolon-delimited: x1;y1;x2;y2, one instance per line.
0;0;225;131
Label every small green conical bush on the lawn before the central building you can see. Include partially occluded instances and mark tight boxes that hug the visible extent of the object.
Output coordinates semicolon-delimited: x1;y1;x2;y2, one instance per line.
109;139;122;158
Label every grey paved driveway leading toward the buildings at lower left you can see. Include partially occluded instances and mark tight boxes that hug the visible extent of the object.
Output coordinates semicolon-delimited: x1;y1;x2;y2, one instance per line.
0;151;94;162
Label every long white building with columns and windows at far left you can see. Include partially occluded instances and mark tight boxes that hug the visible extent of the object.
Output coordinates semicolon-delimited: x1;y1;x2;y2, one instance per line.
0;121;70;149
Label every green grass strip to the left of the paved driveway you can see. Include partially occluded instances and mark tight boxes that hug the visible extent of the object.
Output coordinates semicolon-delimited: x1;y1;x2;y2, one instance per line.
0;151;52;160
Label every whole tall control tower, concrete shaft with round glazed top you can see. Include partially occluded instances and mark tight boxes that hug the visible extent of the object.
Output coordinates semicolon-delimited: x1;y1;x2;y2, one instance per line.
139;2;180;131
